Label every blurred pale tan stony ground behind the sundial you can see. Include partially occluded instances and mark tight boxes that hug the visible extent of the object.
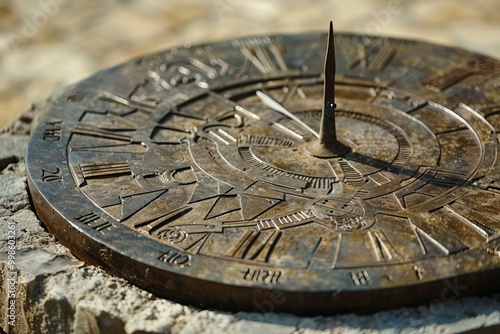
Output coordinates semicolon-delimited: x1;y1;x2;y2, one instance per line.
0;0;500;130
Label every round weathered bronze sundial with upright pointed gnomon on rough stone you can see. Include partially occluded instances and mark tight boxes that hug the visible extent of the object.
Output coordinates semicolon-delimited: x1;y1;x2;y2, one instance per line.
26;26;500;314
